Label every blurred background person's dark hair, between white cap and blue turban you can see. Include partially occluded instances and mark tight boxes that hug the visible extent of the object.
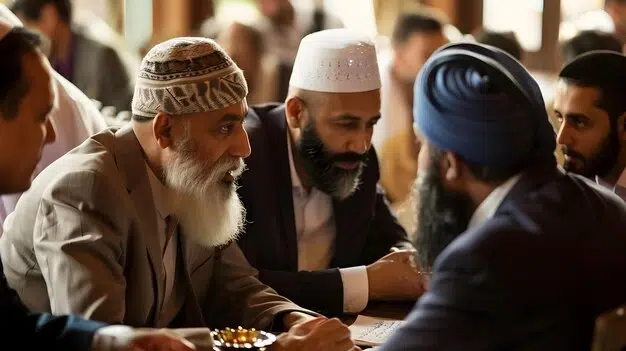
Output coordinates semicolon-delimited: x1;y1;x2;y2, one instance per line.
391;11;446;44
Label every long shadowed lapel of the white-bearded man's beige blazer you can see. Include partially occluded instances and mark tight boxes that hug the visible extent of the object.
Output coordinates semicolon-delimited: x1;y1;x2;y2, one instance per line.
115;124;165;324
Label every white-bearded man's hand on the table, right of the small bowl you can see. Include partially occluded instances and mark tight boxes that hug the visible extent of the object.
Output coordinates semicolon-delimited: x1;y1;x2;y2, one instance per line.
271;317;360;351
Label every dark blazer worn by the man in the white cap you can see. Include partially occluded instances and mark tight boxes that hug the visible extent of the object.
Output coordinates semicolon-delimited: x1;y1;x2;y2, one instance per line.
239;104;411;315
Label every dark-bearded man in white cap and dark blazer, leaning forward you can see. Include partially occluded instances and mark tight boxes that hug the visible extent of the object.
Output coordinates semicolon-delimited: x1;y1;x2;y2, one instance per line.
239;29;422;315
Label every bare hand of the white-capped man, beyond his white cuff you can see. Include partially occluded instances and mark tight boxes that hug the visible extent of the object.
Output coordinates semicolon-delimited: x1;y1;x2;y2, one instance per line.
367;249;425;301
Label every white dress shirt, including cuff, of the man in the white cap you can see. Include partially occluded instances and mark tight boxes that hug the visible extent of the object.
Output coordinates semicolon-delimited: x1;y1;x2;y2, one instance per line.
287;136;369;313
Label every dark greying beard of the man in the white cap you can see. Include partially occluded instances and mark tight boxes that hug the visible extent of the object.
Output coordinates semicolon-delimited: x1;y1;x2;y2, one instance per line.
295;122;367;199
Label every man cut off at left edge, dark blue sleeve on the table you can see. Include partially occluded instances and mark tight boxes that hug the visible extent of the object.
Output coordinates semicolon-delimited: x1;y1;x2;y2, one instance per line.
0;17;193;351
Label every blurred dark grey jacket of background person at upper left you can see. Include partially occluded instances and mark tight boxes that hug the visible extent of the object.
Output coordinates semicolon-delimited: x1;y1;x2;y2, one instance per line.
70;30;134;112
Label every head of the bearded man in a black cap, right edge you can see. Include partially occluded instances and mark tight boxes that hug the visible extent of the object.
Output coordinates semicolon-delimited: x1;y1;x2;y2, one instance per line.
554;51;626;199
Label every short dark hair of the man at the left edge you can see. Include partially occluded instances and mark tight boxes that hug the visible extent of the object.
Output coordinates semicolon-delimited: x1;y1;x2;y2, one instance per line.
0;27;40;119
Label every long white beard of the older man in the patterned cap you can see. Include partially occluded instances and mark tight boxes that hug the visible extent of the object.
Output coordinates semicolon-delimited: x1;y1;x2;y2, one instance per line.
164;139;245;248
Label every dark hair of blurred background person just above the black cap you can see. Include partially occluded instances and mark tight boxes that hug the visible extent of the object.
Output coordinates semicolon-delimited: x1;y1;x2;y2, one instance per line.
561;30;622;63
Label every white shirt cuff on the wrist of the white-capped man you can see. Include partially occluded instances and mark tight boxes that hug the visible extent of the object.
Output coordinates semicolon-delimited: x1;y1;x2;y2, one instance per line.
339;266;369;313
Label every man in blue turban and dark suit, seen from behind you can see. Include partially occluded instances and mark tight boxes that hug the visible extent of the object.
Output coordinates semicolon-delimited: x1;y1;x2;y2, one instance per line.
381;43;626;351
